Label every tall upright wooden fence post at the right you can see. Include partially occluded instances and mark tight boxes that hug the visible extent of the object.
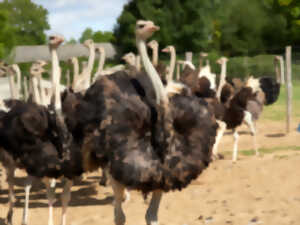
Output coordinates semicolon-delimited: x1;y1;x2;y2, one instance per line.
285;46;293;133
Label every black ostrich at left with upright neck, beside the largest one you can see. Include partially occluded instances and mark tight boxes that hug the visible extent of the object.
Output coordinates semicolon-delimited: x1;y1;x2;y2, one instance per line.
0;36;83;225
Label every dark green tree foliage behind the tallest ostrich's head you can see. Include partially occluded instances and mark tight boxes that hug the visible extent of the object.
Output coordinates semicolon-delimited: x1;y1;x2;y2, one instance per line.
114;0;300;56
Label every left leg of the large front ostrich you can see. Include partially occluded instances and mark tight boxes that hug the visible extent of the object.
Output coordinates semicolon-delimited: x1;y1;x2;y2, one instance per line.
110;177;126;225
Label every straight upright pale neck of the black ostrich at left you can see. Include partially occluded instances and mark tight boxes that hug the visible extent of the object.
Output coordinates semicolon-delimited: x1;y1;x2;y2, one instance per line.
51;49;61;110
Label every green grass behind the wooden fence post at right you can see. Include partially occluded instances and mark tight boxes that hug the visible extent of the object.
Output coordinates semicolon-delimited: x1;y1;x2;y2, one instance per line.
263;80;300;121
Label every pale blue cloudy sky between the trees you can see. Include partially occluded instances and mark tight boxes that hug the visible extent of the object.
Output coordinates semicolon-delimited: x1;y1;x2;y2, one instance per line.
32;0;128;40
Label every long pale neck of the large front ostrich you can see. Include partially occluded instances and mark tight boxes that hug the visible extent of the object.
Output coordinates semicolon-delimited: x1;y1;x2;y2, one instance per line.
136;39;168;104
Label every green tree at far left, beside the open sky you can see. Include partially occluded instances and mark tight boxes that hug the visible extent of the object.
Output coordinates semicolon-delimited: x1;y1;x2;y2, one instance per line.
0;0;50;45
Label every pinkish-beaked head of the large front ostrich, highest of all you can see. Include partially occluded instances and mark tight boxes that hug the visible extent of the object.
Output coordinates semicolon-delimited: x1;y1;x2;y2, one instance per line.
135;20;160;41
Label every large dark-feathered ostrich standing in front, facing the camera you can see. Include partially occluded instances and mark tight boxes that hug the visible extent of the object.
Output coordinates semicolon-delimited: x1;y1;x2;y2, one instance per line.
78;21;217;225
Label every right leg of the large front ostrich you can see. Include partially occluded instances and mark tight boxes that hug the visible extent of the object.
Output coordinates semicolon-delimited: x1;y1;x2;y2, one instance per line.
146;190;162;225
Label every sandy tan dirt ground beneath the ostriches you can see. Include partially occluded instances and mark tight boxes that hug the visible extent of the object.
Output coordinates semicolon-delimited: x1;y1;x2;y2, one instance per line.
0;118;300;225
